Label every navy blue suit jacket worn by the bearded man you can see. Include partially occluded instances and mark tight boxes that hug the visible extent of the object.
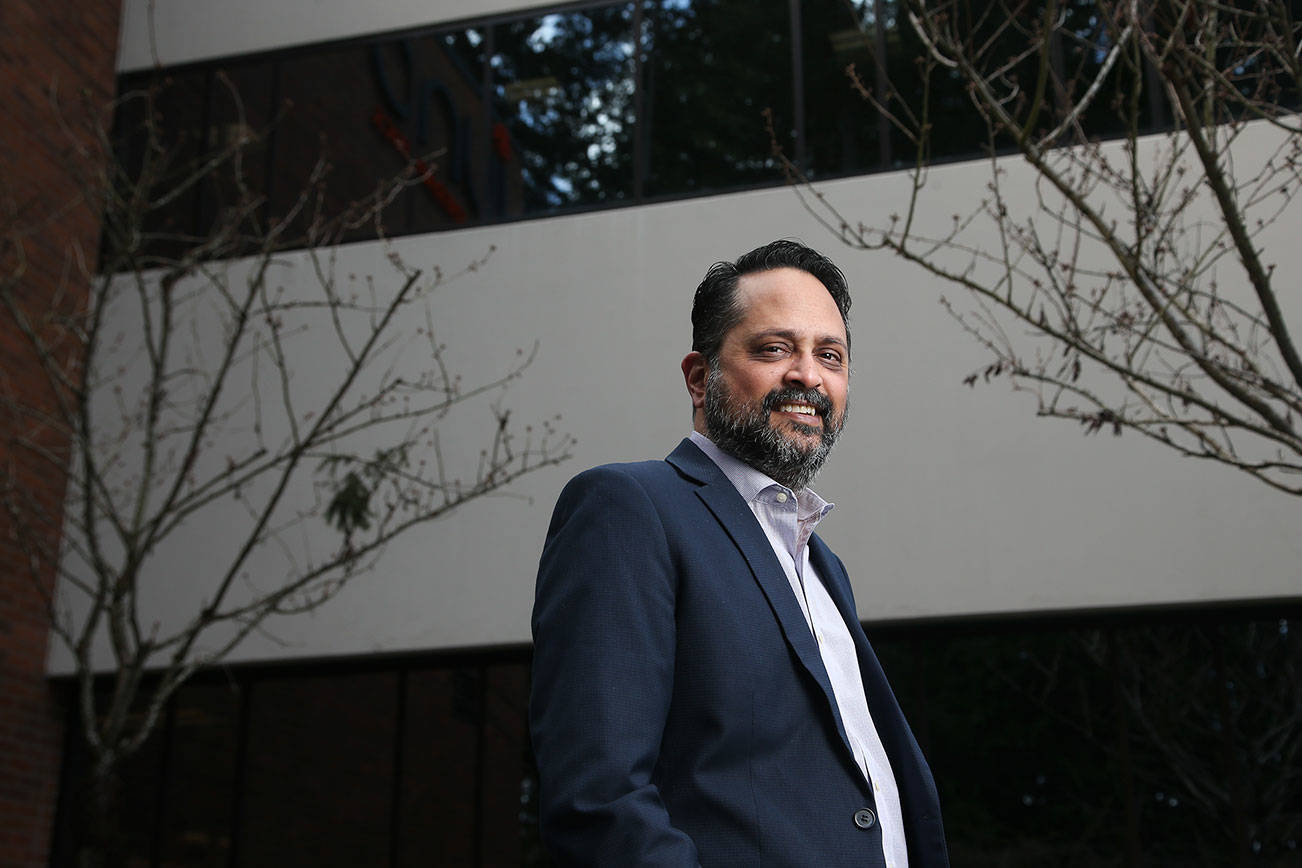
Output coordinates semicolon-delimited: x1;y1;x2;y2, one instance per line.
530;440;949;868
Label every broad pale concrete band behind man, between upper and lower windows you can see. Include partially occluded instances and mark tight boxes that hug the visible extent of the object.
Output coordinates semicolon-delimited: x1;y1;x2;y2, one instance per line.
58;3;1302;673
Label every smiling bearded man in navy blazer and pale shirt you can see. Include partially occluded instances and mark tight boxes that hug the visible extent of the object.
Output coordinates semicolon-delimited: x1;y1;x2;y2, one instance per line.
530;241;948;868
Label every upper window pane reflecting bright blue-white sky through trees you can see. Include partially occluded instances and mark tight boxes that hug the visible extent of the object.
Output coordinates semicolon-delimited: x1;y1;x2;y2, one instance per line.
493;5;634;211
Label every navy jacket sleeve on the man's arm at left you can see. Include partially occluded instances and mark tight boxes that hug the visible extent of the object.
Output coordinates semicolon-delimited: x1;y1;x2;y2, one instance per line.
530;467;698;868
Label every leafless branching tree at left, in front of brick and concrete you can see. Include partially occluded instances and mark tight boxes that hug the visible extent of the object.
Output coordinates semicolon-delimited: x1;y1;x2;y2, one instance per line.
0;74;573;864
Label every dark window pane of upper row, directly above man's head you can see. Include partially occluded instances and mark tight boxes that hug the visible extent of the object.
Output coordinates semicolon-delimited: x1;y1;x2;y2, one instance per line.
643;0;793;195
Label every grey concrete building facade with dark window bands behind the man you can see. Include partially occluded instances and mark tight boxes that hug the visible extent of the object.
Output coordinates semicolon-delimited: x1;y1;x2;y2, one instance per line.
4;0;1302;865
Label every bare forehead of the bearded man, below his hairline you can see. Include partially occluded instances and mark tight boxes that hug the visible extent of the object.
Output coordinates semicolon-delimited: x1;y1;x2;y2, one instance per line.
733;268;845;342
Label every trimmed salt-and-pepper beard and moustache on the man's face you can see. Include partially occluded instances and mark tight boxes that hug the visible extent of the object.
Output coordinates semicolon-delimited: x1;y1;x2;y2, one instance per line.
704;367;845;491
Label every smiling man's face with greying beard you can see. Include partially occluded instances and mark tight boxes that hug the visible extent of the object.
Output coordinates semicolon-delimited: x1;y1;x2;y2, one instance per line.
704;268;850;491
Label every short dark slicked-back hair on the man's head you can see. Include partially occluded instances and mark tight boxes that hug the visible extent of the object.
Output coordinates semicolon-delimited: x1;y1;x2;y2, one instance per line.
691;239;850;364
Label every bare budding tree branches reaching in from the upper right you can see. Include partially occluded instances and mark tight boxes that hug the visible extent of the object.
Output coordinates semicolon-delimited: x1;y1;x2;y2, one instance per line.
775;0;1302;495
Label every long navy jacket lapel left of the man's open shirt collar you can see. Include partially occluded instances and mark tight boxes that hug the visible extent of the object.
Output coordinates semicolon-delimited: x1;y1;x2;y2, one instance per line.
667;440;850;750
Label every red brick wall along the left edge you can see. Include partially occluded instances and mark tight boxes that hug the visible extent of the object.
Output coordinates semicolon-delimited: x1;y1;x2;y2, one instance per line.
0;0;120;868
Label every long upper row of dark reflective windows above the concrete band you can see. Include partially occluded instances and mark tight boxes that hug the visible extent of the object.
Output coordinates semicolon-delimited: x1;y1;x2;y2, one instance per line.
105;0;1265;259
